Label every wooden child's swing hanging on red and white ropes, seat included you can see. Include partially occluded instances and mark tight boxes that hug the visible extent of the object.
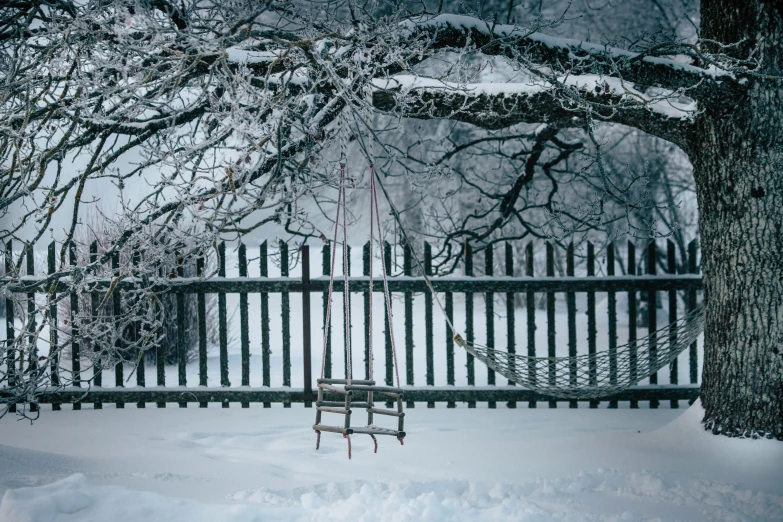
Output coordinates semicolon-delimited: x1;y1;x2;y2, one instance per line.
313;162;405;459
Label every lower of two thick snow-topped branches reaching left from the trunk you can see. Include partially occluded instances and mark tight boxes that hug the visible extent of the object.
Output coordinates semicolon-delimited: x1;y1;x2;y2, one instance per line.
373;75;697;143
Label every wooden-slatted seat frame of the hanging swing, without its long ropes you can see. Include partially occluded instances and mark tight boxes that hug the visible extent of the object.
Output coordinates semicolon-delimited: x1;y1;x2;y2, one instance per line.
313;379;405;451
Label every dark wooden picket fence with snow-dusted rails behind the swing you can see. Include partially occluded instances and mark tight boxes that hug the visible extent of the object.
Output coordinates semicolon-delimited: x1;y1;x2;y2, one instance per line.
0;241;702;409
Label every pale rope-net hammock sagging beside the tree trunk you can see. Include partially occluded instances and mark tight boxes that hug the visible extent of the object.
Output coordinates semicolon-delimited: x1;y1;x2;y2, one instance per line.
455;306;704;399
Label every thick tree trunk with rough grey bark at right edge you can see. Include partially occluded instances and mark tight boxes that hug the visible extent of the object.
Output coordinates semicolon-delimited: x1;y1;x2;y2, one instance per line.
689;0;783;440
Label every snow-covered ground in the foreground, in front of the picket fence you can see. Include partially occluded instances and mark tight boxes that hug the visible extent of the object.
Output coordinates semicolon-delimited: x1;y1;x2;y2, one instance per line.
0;403;783;522
